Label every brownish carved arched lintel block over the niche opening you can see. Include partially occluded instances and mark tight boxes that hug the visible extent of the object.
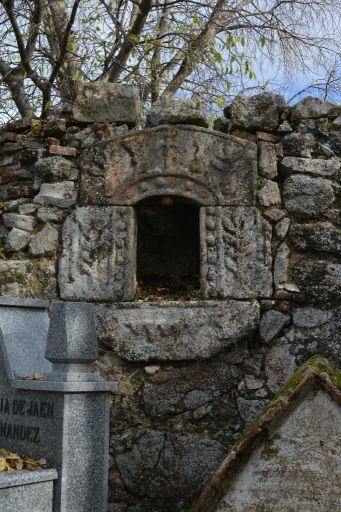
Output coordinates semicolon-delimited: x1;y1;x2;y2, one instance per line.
81;125;257;205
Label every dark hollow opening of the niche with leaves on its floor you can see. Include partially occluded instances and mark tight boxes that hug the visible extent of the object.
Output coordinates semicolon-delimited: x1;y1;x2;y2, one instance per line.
135;196;200;300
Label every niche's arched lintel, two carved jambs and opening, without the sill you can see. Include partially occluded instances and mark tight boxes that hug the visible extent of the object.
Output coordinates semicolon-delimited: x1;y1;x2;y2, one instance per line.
59;126;272;302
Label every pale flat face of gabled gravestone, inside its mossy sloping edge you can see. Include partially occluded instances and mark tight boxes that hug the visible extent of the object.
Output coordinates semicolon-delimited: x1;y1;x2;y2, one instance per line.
214;391;341;512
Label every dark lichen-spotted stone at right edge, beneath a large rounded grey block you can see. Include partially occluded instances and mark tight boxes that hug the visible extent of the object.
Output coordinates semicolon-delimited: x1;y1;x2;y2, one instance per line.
290;222;341;254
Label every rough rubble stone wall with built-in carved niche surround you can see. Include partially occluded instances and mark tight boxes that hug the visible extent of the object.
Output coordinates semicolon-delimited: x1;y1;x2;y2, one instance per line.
0;92;341;512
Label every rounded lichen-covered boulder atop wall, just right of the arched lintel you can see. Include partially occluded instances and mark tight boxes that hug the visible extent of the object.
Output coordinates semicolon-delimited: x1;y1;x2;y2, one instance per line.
224;92;285;132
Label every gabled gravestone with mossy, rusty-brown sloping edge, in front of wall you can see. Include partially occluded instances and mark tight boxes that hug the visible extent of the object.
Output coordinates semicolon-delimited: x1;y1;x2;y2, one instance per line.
193;356;341;512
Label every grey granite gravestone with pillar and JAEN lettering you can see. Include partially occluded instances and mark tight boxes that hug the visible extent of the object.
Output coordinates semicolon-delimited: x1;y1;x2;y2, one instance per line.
0;298;115;512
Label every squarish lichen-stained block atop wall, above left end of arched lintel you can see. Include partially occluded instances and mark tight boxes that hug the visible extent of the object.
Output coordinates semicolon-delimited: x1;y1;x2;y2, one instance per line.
73;82;141;125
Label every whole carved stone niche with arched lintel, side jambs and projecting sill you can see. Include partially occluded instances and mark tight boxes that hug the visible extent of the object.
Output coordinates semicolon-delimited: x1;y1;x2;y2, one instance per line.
59;125;272;361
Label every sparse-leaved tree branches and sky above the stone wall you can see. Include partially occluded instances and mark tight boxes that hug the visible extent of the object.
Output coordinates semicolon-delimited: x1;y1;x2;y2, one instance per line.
0;0;341;120
